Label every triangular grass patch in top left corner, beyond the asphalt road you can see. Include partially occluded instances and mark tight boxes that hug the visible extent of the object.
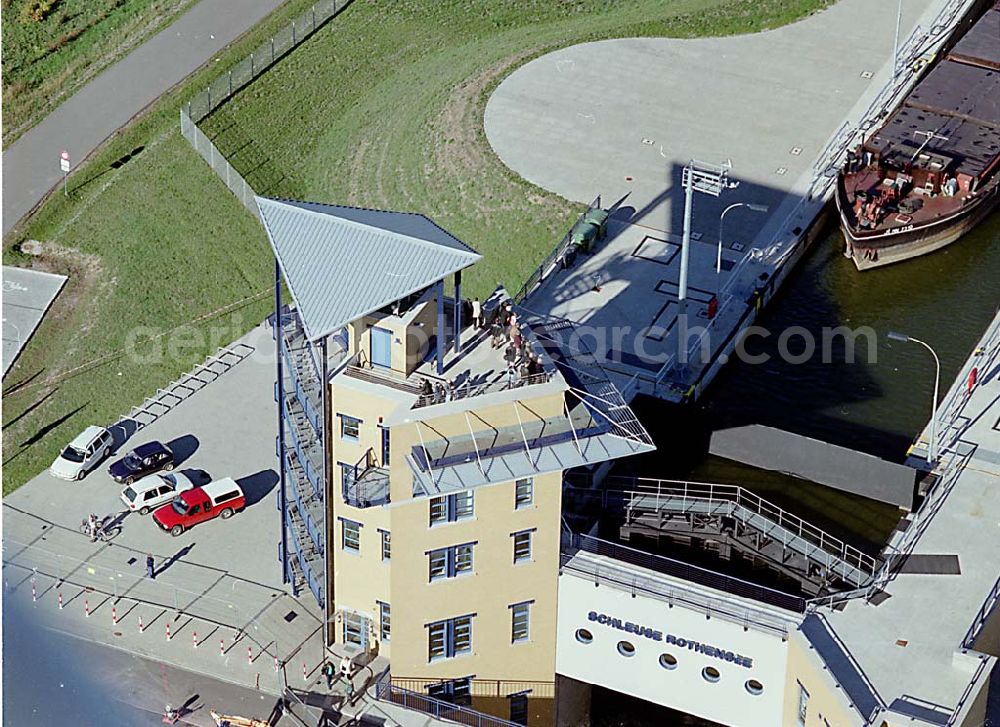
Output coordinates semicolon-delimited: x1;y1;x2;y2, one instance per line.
3;0;195;147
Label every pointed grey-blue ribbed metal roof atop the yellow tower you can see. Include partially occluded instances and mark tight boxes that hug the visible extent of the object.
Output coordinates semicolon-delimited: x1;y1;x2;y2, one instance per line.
256;197;481;341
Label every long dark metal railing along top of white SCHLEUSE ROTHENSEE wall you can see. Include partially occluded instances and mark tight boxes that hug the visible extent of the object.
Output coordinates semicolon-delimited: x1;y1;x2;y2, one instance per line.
562;533;806;626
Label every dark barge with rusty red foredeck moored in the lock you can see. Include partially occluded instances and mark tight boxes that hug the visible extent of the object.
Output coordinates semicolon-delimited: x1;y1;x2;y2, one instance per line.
836;0;1000;270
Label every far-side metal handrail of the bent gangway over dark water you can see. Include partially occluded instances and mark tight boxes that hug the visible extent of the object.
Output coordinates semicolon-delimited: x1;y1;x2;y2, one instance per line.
627;478;878;575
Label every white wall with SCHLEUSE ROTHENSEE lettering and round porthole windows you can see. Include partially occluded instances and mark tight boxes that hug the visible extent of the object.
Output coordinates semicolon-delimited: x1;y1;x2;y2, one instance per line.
556;573;788;727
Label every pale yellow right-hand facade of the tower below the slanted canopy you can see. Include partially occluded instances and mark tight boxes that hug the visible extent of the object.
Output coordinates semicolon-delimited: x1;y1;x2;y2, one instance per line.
390;473;562;681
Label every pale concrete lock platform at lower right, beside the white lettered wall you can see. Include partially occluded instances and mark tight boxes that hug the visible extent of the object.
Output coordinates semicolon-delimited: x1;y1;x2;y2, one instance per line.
810;314;1000;725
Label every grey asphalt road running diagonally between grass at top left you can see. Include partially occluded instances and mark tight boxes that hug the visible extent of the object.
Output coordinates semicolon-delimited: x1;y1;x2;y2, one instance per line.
3;0;284;235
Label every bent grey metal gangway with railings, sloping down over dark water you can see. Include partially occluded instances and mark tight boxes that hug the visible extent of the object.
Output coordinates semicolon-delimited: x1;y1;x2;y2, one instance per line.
625;478;880;588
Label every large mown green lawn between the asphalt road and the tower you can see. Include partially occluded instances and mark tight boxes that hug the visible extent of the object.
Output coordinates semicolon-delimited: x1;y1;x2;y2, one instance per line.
3;0;828;492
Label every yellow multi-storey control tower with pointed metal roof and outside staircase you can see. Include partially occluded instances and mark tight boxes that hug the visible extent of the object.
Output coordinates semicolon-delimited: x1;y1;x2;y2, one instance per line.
258;198;653;724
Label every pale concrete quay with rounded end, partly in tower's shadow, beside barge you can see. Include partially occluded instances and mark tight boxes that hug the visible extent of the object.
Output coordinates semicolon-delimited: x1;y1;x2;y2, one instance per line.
485;0;969;401
